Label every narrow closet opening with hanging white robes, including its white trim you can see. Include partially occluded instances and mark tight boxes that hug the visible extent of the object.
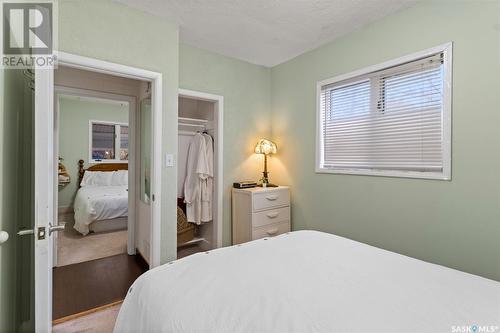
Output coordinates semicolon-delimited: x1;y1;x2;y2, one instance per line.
177;89;223;258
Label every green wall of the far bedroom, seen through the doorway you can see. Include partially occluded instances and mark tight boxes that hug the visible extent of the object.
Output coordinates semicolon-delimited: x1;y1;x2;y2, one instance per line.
58;98;129;207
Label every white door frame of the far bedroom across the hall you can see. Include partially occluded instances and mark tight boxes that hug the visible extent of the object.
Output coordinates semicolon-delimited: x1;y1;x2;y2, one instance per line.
53;85;137;267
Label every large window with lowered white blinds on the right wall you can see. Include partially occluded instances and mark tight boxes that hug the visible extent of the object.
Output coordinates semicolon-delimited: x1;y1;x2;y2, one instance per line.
317;45;451;179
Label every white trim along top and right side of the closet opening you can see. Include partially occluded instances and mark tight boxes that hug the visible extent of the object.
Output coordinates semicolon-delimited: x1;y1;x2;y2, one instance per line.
179;89;224;247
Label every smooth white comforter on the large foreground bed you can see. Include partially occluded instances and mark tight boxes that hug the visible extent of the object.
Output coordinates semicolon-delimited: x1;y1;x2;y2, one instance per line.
115;231;500;332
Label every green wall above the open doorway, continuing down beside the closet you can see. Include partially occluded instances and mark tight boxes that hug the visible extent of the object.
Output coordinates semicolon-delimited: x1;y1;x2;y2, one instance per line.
59;0;179;262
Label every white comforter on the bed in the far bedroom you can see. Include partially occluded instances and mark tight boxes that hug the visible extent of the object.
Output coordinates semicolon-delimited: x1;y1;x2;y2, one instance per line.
74;185;128;235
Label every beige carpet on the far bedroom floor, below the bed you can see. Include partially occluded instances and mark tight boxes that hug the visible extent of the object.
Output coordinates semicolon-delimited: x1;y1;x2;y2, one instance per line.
57;214;127;267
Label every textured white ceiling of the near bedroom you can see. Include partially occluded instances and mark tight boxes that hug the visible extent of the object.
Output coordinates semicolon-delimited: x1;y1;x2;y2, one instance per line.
116;0;418;66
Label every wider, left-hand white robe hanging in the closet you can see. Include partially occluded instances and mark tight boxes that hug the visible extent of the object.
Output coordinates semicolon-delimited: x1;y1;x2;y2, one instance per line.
184;133;209;224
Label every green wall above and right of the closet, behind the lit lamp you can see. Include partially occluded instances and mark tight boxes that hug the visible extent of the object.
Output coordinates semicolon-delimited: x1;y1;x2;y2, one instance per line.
179;44;273;245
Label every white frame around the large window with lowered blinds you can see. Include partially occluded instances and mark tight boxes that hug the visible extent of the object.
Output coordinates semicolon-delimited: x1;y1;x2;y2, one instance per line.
315;42;453;180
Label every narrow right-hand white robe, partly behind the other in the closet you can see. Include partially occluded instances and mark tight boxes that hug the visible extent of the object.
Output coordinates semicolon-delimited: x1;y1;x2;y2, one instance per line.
201;134;214;222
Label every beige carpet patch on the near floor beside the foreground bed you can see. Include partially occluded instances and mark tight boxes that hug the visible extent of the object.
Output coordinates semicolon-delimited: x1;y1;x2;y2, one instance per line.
52;303;121;333
